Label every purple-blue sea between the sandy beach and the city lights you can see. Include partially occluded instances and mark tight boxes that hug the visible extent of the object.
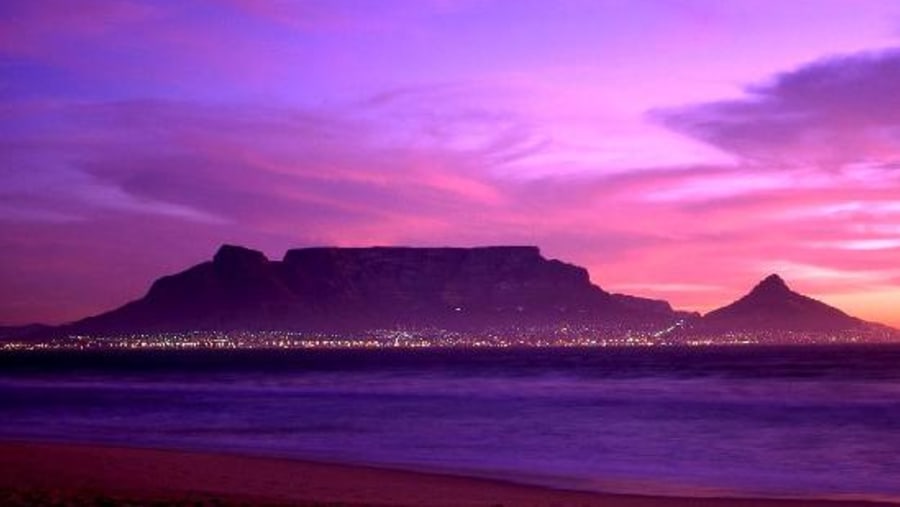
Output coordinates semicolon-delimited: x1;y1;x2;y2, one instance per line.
0;346;900;500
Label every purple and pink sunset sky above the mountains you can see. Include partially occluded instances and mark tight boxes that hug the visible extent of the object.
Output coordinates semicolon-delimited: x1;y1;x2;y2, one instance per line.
0;0;900;326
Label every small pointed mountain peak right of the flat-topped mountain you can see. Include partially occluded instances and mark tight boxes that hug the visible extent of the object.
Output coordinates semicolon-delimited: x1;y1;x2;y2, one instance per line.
701;275;868;331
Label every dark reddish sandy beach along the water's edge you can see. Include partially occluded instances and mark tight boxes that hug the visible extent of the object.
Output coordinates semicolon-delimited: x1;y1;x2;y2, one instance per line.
0;442;890;507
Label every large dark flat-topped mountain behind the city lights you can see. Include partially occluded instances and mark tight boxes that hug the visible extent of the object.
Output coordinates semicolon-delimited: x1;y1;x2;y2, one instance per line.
58;245;679;334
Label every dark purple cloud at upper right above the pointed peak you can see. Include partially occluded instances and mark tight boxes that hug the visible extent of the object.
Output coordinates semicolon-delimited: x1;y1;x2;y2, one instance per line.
651;48;900;166
